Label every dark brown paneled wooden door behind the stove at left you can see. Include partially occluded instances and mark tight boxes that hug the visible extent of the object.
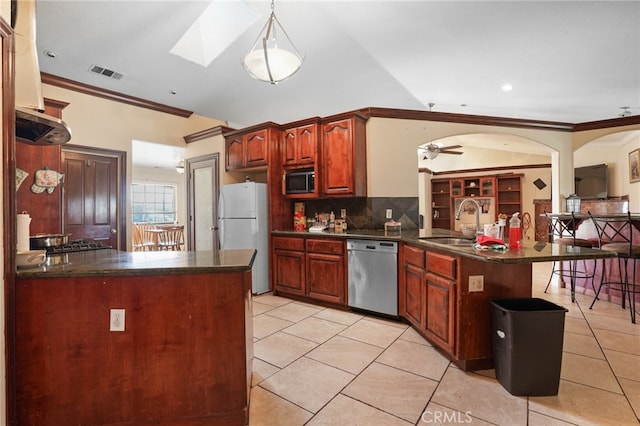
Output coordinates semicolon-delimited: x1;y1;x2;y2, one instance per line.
62;148;126;249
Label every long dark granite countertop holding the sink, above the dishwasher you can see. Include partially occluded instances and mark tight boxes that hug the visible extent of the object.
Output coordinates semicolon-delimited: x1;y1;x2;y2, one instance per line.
271;229;615;263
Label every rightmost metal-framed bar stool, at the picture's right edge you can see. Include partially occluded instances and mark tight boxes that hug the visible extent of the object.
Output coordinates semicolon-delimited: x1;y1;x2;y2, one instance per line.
588;212;640;324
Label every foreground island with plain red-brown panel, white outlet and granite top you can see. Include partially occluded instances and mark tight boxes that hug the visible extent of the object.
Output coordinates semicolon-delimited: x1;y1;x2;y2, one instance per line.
15;250;255;425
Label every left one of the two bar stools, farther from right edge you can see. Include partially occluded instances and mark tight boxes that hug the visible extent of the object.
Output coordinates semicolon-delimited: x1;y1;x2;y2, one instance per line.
544;213;596;302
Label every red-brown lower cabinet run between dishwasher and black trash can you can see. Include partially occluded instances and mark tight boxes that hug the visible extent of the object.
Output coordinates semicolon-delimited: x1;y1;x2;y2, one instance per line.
398;244;532;370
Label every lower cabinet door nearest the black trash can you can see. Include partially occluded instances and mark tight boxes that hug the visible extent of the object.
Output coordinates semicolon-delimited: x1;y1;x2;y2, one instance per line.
425;272;455;353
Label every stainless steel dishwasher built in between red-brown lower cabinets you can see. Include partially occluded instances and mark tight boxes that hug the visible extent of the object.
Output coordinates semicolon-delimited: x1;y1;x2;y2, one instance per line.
347;240;398;315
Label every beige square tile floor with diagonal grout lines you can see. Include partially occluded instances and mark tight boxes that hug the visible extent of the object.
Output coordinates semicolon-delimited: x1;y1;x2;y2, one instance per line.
250;263;640;426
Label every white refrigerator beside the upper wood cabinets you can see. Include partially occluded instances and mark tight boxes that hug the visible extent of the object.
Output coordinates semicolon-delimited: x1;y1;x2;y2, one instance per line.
218;182;269;294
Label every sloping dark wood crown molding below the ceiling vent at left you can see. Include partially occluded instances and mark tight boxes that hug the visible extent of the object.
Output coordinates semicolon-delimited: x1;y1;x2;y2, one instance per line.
40;72;193;118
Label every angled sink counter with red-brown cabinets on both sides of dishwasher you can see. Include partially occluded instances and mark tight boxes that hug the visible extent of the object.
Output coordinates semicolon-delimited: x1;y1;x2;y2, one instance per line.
271;229;613;370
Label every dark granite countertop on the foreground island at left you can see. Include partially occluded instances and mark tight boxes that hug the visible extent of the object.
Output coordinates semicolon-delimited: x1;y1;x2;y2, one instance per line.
17;249;256;279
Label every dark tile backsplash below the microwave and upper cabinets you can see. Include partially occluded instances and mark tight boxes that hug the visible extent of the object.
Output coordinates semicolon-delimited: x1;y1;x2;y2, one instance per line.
304;197;419;229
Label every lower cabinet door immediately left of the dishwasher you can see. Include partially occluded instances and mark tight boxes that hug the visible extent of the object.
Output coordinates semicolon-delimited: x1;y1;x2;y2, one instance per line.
307;253;346;304
